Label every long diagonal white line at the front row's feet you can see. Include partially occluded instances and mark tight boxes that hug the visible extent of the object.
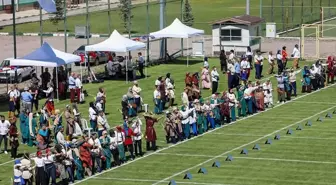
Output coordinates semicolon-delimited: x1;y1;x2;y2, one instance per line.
73;84;336;184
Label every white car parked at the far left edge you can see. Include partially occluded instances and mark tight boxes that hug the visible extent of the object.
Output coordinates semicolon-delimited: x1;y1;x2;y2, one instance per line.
0;58;35;83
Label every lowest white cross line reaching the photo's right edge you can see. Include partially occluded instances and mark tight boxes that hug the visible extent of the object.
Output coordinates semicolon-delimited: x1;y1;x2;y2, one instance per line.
156;153;336;164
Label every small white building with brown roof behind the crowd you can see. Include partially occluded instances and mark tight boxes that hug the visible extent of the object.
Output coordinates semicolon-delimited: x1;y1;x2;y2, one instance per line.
212;15;263;55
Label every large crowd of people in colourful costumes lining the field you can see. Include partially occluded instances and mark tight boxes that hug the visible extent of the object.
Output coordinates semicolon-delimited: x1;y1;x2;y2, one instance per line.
0;43;336;185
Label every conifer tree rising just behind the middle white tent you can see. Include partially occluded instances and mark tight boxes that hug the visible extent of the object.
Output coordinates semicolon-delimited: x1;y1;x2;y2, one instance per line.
118;0;133;32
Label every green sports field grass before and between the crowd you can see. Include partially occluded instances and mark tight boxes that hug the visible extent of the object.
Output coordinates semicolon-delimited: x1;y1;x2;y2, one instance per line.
0;59;336;185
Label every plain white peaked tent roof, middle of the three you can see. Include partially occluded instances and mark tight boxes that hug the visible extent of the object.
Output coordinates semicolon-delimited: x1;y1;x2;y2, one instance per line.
85;30;146;52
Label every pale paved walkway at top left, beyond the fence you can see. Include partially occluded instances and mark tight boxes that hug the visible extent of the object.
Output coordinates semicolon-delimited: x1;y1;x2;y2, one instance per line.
0;0;152;27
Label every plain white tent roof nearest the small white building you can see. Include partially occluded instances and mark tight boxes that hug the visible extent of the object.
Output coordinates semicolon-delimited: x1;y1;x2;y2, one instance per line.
149;18;204;38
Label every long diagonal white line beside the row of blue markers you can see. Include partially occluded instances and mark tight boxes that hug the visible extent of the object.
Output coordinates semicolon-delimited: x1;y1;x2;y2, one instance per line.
153;106;336;185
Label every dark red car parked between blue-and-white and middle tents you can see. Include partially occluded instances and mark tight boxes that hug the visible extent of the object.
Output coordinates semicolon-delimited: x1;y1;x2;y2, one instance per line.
73;45;111;66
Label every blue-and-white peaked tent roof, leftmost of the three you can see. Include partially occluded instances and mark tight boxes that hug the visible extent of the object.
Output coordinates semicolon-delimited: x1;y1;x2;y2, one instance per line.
10;42;81;67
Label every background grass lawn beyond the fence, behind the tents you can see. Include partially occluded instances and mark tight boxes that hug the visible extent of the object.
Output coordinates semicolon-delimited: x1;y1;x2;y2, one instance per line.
1;0;259;34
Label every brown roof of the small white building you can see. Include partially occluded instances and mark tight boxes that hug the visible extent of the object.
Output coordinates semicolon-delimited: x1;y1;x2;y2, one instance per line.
212;15;264;25
